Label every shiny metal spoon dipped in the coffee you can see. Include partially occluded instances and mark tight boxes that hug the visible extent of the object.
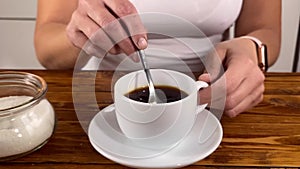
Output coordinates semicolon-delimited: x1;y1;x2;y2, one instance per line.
138;50;159;103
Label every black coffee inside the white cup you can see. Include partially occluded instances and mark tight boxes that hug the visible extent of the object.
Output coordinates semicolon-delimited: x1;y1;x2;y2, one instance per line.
125;86;188;103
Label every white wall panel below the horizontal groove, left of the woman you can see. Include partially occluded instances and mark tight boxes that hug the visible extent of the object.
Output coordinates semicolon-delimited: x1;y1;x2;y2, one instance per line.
0;20;42;69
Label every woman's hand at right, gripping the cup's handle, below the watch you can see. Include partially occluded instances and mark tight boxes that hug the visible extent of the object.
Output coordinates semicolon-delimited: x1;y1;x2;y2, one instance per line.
199;38;265;117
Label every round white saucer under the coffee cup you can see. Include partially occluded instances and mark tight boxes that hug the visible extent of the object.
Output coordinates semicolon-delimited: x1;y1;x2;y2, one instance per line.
88;105;223;168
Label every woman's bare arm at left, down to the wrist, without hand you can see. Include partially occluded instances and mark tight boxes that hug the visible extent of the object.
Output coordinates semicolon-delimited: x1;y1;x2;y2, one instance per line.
34;0;80;69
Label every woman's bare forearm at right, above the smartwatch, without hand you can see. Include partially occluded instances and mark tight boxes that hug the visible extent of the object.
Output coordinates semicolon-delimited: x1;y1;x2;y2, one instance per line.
235;0;281;66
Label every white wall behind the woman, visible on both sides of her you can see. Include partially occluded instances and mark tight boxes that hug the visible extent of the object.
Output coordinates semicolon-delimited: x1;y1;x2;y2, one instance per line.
0;0;300;72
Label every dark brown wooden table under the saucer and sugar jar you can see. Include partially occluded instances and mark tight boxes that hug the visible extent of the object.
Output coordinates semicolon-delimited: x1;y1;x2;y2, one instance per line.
0;70;300;169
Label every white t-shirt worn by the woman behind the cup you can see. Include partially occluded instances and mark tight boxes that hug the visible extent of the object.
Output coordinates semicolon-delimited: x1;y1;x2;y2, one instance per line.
83;0;243;71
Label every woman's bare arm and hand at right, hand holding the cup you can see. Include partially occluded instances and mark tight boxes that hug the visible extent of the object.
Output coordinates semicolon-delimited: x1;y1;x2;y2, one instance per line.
199;0;281;117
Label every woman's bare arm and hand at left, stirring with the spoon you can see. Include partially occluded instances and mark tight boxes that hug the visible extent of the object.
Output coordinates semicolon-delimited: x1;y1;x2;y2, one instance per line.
35;0;147;69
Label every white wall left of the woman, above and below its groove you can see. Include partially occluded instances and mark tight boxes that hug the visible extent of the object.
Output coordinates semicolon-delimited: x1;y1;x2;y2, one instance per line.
0;0;43;69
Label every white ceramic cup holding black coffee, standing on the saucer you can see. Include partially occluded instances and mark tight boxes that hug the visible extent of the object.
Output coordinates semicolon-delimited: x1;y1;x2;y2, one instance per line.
114;69;208;149
